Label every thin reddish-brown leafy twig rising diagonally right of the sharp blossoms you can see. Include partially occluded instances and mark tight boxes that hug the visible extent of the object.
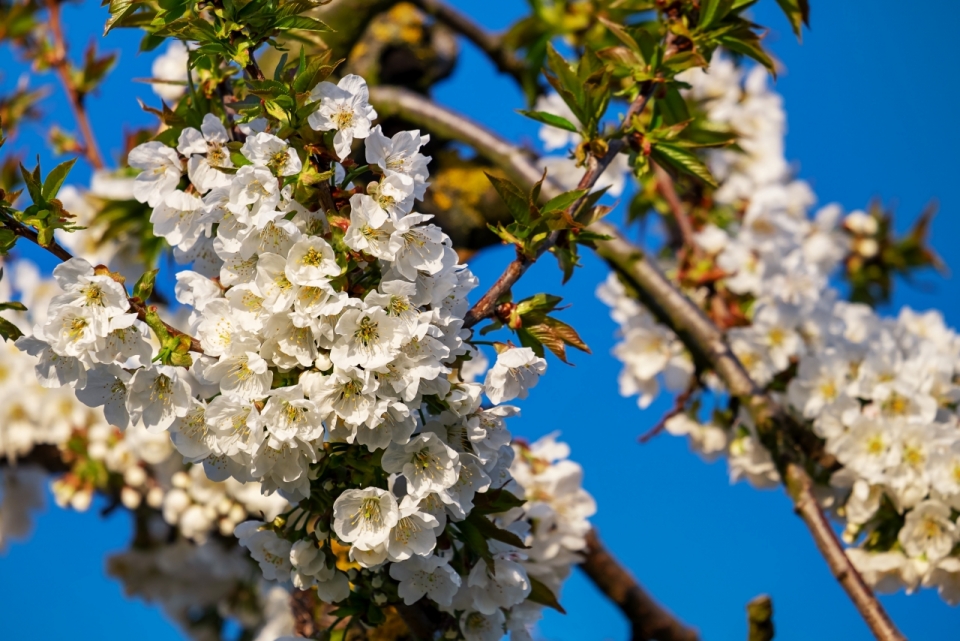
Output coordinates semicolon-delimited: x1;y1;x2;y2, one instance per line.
463;83;656;327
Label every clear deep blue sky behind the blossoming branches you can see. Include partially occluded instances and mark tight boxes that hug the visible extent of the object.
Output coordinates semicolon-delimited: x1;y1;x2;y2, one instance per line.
0;0;960;641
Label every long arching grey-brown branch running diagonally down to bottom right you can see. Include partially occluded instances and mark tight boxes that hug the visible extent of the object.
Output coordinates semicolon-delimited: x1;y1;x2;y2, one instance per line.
362;90;904;641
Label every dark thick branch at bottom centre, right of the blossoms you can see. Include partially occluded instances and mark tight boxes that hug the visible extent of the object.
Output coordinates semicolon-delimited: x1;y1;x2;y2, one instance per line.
580;530;699;641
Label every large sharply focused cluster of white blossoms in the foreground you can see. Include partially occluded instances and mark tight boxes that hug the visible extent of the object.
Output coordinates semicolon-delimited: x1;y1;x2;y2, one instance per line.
9;75;594;641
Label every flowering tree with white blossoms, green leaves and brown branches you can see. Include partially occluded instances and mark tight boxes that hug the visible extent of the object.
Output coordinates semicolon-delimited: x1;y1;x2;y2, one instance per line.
0;0;948;641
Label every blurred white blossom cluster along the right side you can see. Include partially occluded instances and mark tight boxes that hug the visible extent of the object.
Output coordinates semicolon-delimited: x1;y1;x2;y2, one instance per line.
599;60;960;604
